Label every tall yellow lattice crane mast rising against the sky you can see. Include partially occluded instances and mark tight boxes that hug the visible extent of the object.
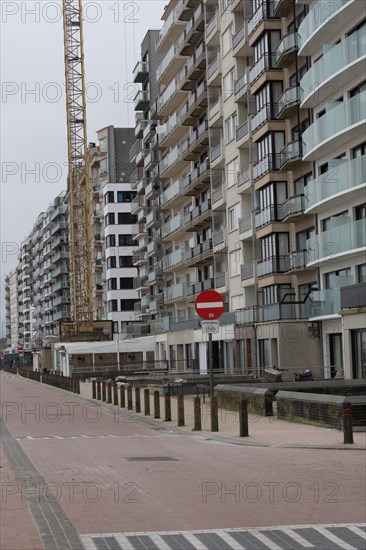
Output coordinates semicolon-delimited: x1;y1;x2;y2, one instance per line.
63;0;93;335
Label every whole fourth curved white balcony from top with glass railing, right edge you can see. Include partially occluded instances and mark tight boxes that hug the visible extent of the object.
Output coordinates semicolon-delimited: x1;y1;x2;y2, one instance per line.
306;155;366;214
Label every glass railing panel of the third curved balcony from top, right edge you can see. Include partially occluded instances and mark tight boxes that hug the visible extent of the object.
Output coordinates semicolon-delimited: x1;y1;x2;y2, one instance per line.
303;91;366;160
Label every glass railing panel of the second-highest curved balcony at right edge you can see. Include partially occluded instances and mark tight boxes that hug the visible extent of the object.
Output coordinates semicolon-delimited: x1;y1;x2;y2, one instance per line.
300;25;366;101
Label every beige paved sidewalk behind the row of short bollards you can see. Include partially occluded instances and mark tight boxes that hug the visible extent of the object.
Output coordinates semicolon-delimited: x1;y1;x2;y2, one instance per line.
81;382;366;449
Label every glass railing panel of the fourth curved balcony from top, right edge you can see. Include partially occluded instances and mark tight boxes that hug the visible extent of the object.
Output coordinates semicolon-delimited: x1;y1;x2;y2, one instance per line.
306;155;366;209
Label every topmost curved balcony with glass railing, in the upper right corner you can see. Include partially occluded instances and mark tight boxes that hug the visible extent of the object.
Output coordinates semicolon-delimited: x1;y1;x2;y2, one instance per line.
299;0;361;55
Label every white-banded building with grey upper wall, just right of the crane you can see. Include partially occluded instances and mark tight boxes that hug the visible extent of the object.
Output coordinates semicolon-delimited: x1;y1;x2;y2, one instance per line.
89;126;138;334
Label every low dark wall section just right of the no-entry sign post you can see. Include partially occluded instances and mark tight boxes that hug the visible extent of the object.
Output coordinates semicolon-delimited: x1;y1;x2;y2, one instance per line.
215;384;275;416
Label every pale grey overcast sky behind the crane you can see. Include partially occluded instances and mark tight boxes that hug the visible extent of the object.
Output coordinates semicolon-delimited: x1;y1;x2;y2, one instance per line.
0;0;168;336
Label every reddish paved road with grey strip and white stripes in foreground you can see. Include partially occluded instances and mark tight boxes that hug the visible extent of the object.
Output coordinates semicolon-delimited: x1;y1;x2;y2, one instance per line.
0;374;365;550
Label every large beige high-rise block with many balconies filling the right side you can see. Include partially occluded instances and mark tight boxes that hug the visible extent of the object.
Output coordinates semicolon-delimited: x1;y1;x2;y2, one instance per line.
132;0;366;378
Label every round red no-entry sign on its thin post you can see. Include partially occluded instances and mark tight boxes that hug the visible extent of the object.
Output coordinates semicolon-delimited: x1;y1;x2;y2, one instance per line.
194;290;224;399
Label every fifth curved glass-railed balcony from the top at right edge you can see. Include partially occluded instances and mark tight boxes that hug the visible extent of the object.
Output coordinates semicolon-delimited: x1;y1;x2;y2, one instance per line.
306;218;366;267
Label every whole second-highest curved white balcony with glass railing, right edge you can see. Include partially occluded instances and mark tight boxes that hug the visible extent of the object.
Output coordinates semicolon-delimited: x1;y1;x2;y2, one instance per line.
300;28;366;109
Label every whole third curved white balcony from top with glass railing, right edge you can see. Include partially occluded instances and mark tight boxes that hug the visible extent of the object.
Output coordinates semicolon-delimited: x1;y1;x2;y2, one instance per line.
302;91;366;160
